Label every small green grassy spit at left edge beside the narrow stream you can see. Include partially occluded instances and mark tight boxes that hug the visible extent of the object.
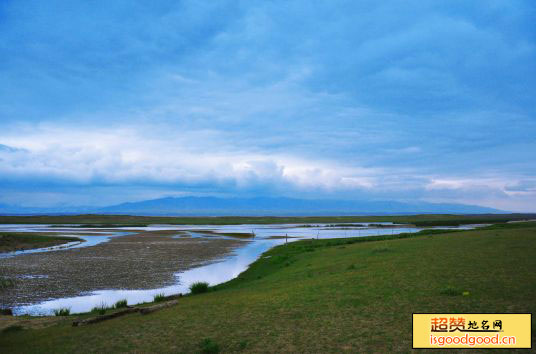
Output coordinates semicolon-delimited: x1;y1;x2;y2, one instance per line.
0;232;81;253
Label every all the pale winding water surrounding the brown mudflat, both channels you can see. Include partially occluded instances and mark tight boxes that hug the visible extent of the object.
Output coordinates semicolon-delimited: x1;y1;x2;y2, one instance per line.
0;223;479;316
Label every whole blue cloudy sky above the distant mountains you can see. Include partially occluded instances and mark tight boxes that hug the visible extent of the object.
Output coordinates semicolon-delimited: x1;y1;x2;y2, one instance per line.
0;0;536;212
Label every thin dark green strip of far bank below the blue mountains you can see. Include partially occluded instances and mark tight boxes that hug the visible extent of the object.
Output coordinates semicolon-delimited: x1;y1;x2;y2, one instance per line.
0;214;536;227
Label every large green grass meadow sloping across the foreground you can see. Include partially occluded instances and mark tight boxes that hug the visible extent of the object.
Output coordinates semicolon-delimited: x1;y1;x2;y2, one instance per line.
0;223;536;353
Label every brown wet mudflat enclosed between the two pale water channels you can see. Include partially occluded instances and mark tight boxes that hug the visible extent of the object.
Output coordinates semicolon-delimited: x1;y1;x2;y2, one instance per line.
0;230;244;308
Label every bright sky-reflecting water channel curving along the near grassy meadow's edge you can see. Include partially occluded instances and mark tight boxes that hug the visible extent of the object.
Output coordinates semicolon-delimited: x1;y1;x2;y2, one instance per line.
3;223;479;315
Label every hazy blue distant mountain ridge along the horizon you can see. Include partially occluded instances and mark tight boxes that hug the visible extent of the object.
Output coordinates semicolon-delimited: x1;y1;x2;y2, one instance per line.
0;197;504;216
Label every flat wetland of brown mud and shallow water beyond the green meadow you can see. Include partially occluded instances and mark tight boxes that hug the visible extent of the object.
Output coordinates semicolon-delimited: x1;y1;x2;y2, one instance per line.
0;215;526;315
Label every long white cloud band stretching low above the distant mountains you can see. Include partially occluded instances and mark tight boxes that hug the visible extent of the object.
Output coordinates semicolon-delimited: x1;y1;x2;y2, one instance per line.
0;121;532;210
